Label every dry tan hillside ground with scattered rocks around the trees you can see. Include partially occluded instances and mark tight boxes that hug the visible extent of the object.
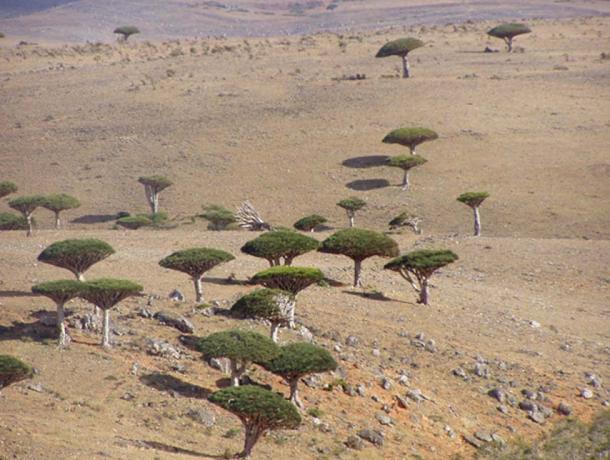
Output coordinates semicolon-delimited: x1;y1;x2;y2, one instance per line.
0;2;610;459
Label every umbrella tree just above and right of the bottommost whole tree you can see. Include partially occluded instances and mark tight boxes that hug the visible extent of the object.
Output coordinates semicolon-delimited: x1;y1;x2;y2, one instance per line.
263;342;337;408
